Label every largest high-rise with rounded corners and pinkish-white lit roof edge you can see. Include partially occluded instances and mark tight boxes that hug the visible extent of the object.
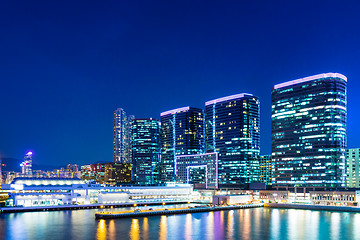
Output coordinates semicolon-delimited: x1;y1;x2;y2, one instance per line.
272;73;347;189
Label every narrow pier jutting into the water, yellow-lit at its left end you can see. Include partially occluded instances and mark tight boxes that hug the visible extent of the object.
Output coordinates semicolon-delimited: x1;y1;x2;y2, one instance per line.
95;204;263;219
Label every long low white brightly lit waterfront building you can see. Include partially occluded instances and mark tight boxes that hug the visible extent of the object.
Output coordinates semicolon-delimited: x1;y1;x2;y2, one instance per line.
2;178;194;207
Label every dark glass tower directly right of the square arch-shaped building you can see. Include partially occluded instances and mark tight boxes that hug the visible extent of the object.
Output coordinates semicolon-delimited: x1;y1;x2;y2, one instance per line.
205;93;260;188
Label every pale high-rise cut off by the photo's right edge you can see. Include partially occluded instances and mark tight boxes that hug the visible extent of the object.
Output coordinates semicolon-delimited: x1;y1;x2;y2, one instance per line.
346;148;360;188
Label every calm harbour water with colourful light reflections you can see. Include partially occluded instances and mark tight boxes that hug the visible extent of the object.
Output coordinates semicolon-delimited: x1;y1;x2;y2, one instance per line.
0;204;360;240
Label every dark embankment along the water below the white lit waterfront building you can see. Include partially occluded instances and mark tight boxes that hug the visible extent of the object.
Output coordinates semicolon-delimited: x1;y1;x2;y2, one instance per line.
0;201;188;213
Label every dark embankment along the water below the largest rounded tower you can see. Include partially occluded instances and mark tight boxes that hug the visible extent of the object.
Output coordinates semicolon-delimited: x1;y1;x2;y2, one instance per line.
264;203;360;212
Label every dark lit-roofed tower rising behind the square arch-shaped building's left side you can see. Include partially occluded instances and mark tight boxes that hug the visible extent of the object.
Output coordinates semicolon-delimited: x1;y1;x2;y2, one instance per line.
160;107;204;182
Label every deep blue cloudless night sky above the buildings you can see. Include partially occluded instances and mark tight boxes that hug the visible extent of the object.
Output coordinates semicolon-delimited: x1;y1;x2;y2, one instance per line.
0;0;360;168
